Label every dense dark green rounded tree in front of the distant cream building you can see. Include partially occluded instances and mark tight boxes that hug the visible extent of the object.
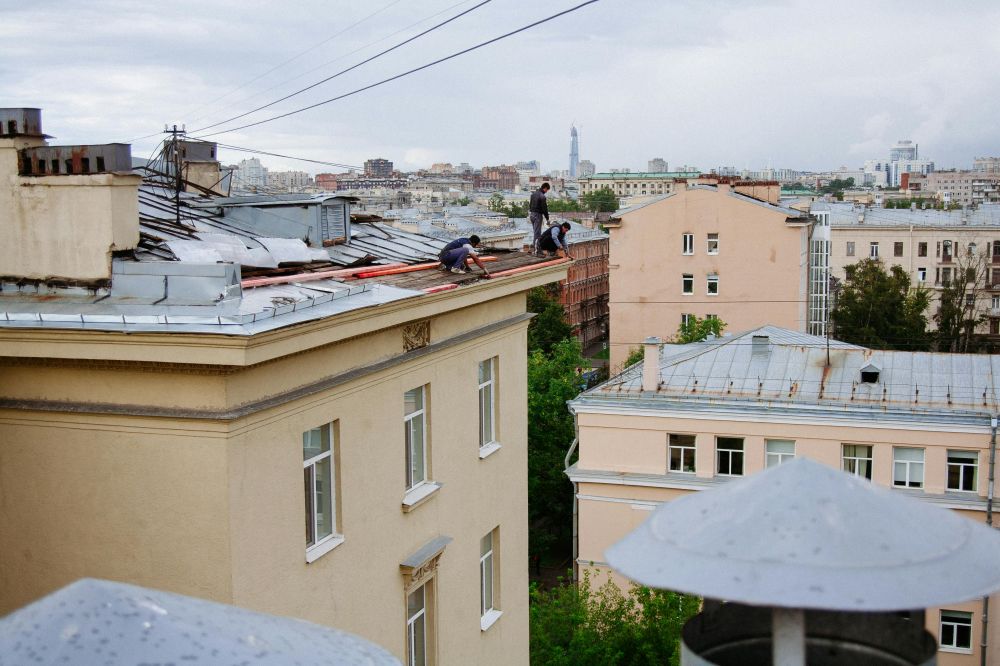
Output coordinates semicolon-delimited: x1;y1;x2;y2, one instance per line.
830;259;930;351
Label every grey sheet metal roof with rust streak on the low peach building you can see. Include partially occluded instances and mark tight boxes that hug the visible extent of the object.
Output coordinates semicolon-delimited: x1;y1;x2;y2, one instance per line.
576;326;1000;415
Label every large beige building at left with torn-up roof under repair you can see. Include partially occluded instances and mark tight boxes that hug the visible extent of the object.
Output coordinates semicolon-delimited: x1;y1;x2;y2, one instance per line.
0;109;566;666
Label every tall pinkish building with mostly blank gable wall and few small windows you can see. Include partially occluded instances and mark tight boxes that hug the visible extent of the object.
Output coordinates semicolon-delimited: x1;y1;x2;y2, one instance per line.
605;178;812;367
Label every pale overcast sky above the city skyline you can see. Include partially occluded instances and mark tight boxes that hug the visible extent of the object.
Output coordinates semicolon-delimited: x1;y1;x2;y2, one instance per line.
0;0;1000;172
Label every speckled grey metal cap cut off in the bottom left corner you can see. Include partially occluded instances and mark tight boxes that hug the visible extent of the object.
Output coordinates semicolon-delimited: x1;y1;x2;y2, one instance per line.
0;579;399;666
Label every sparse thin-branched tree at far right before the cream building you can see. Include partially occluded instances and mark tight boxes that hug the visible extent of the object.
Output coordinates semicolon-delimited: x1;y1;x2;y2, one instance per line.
934;247;993;354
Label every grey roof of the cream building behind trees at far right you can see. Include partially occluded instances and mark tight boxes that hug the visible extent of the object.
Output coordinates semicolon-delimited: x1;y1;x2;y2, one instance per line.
809;201;1000;229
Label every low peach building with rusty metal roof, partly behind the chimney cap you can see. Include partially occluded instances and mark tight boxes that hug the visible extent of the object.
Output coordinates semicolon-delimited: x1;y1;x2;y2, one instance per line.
567;326;1000;666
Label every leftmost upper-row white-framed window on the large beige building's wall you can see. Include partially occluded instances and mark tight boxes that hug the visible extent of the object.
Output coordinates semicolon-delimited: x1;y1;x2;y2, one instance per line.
302;423;340;562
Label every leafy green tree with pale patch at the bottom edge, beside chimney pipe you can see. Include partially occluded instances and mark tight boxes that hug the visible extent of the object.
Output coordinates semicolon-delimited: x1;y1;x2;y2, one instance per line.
530;571;701;666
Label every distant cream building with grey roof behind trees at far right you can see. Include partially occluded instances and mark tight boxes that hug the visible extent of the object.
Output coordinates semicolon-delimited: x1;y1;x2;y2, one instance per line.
808;201;1000;335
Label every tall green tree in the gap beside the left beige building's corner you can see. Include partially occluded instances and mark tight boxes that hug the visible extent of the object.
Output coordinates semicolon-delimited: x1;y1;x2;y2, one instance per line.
528;338;587;557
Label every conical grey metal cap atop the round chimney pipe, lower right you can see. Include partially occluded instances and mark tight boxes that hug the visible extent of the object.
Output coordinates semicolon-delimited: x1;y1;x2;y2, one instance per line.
605;458;1000;611
